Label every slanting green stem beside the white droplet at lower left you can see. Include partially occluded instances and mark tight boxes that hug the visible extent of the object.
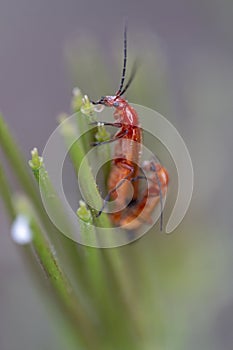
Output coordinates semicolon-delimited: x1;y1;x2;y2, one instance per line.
0;160;98;350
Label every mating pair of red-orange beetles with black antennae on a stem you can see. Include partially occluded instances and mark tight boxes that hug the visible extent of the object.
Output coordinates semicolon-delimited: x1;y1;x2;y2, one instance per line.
91;26;168;229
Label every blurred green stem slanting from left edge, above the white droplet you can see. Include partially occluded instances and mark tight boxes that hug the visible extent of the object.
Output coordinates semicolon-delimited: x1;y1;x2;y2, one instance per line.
0;117;97;330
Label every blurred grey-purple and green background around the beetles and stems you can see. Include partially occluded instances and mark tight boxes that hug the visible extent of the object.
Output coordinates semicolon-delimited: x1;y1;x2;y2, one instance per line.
0;0;233;350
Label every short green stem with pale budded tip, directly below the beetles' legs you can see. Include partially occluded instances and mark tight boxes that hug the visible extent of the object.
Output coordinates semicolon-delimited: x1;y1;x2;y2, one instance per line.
80;215;138;350
